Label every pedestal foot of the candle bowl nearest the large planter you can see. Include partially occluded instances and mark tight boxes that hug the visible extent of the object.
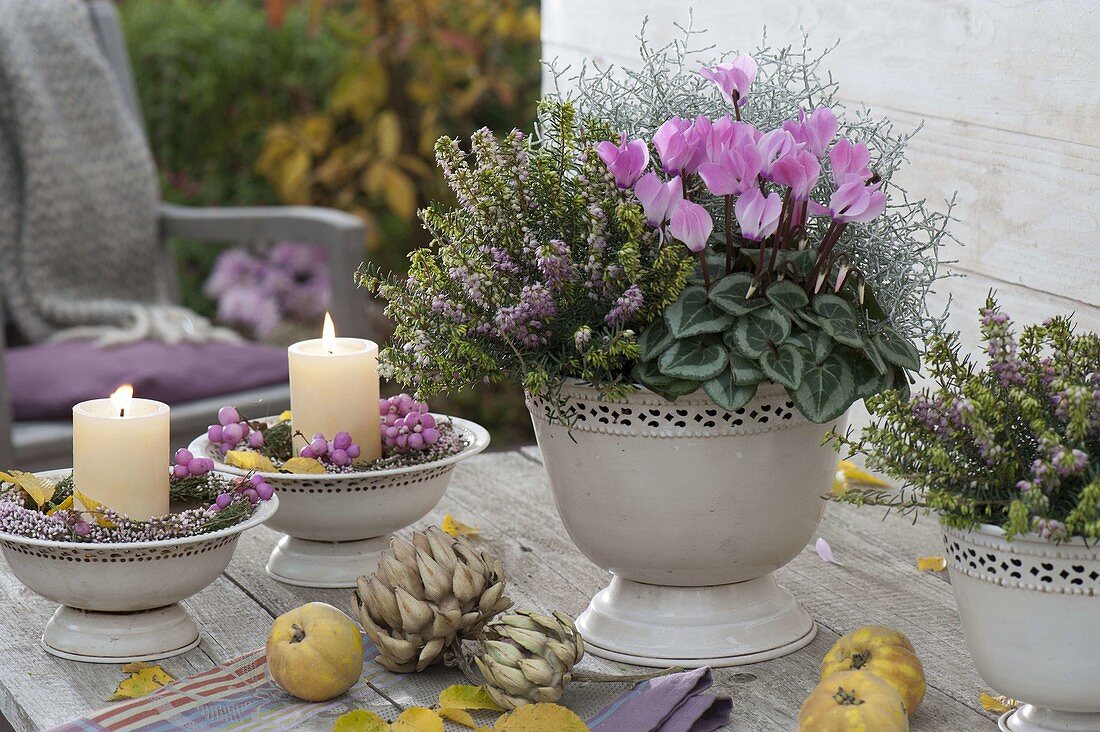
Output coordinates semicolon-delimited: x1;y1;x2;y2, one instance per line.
267;534;392;589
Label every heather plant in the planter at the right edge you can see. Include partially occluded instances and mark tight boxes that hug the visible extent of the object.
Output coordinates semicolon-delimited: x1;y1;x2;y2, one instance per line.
834;295;1100;540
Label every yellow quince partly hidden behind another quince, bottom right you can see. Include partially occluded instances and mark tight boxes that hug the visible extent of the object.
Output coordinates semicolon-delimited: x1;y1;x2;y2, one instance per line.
822;625;925;717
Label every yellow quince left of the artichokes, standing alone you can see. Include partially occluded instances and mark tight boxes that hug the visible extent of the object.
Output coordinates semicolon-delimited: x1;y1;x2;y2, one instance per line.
267;602;363;701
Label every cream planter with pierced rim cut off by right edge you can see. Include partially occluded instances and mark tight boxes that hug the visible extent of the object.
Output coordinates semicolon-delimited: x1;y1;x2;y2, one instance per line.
944;526;1100;732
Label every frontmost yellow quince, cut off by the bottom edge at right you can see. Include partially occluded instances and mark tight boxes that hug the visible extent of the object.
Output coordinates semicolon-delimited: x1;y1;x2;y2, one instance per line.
799;671;909;732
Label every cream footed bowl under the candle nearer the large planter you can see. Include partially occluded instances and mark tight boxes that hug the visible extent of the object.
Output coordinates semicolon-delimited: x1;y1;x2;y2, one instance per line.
190;415;490;588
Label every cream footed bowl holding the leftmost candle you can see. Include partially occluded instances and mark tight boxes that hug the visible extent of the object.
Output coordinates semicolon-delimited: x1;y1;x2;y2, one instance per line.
0;470;278;664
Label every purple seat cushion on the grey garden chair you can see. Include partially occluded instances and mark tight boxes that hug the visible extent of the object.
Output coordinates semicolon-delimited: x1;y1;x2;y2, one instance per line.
4;340;287;420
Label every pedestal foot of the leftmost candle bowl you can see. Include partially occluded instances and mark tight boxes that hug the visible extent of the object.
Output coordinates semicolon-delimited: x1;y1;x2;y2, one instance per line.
42;604;199;664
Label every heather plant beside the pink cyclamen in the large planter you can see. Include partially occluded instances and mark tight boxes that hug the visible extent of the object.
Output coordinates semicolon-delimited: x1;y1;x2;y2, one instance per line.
360;102;692;395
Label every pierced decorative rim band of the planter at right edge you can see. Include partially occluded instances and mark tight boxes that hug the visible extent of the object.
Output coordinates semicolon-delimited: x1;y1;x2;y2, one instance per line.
944;528;1100;597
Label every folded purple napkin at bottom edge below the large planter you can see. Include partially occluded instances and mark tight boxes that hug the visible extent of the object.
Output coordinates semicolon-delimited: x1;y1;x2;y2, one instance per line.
590;666;734;732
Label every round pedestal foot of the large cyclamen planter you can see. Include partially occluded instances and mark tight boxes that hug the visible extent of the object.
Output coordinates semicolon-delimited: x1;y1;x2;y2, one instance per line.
576;575;817;667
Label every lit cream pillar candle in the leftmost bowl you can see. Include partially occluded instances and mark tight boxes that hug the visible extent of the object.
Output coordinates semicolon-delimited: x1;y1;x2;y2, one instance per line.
73;385;171;521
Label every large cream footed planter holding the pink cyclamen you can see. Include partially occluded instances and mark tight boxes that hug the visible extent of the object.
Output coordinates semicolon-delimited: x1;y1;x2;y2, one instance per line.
527;382;846;666
